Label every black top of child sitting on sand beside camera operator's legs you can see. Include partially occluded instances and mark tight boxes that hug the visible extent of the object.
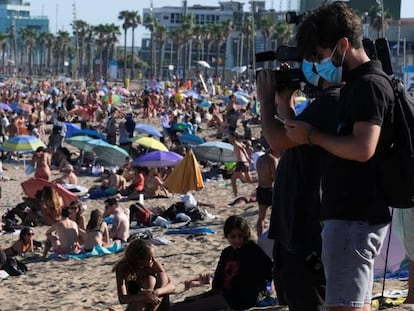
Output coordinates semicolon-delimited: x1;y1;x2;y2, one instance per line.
212;241;272;310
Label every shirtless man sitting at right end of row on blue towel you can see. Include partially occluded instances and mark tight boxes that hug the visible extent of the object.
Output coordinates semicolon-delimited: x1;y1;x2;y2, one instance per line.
103;198;129;243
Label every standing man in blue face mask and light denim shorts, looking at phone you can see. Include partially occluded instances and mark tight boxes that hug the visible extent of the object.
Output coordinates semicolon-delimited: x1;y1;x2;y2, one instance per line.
285;1;394;311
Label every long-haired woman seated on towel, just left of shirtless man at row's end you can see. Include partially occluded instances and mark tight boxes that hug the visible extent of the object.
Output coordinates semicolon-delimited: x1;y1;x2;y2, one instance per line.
83;209;112;252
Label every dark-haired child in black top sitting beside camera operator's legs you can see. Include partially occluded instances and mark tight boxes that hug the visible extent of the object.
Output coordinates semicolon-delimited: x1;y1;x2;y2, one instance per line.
170;215;272;311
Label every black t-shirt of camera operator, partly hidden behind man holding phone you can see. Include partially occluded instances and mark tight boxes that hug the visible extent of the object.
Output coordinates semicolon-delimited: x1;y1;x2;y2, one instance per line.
269;87;340;254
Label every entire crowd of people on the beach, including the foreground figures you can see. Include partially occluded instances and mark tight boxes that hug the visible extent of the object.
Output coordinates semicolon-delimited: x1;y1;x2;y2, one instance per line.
1;2;414;311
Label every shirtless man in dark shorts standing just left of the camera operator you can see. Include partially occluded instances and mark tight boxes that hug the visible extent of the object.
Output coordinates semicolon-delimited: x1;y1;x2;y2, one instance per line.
256;149;280;237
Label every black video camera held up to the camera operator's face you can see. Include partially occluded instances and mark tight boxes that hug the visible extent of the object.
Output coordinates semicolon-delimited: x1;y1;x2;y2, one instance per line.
255;45;306;89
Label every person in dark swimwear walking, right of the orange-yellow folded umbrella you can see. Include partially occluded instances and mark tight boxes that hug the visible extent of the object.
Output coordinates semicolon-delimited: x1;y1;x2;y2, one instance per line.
229;132;253;197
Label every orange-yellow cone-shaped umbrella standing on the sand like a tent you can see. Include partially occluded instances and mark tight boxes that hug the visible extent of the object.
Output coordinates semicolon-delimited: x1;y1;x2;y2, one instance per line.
164;149;204;193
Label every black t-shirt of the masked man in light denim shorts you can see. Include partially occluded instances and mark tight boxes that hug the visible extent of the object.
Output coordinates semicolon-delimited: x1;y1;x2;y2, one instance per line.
322;61;394;224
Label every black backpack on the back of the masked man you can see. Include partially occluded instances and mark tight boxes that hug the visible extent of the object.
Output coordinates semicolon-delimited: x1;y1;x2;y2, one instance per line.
374;71;414;208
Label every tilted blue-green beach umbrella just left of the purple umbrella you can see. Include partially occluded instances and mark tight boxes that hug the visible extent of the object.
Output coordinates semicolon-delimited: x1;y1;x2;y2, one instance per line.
84;139;129;166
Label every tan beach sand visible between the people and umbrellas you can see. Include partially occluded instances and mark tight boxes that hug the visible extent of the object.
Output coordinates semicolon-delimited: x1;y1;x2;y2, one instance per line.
0;119;406;311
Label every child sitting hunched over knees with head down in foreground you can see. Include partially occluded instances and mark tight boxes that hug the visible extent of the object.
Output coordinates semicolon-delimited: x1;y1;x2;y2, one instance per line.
112;239;175;311
